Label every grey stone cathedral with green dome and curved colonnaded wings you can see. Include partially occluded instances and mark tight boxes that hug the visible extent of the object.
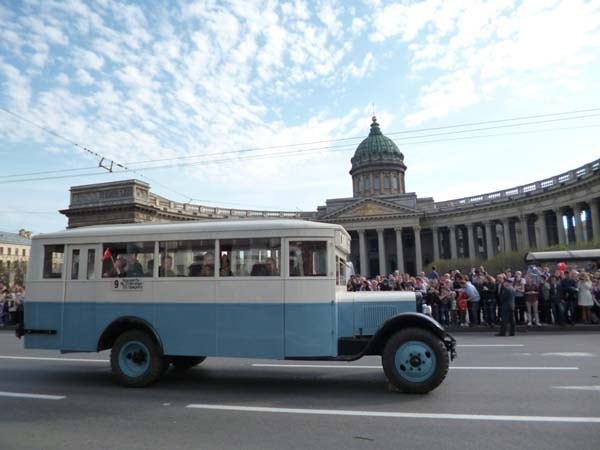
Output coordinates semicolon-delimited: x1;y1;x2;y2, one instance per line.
61;117;600;276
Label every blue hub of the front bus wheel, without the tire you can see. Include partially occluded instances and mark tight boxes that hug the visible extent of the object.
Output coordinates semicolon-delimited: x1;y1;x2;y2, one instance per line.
395;341;437;383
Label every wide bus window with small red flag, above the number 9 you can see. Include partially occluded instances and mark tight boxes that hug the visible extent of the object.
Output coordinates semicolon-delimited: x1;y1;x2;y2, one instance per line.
102;242;154;278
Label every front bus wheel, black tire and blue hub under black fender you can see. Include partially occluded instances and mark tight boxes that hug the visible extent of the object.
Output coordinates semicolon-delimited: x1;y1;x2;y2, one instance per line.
381;328;450;394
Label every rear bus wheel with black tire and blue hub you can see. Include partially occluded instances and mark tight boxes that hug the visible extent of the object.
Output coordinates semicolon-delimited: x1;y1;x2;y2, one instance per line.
110;330;168;387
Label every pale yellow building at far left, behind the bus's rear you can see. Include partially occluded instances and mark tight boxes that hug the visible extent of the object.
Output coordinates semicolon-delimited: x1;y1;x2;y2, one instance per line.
0;230;31;285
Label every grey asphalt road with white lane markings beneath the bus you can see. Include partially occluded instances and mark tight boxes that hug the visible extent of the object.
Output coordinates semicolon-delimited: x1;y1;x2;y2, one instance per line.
0;332;600;450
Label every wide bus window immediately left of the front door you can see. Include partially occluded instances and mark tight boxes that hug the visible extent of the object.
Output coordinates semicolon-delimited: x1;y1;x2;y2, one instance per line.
219;238;281;277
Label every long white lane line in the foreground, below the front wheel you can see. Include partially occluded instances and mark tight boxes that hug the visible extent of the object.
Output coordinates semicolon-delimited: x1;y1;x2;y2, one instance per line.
186;403;600;423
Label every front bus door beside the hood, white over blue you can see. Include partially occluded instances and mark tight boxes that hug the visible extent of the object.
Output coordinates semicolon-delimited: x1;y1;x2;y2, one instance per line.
283;238;337;358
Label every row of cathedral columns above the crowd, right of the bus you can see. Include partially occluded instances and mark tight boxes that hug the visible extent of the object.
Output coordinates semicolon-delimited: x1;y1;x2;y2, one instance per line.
348;197;600;277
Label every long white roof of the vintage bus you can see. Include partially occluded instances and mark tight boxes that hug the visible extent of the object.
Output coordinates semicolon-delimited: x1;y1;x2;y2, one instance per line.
33;219;349;240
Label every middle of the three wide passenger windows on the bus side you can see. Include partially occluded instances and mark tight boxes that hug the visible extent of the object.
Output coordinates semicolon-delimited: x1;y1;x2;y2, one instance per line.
158;240;215;278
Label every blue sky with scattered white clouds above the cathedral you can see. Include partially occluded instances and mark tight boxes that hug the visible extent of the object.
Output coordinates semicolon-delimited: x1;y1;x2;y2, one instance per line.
0;0;600;233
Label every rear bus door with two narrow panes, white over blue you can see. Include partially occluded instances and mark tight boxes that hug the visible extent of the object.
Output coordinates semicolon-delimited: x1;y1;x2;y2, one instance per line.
61;244;100;351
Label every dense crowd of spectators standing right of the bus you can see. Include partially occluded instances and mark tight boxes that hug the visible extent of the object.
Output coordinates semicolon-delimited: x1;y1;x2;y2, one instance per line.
347;264;600;332
